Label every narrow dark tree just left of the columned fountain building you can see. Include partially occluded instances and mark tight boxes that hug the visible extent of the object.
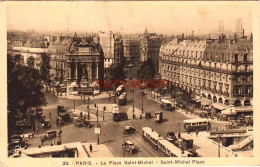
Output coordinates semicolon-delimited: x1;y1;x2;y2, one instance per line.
40;54;51;91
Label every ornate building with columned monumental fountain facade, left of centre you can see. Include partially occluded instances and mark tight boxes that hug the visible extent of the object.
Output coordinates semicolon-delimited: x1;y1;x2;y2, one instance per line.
48;33;104;83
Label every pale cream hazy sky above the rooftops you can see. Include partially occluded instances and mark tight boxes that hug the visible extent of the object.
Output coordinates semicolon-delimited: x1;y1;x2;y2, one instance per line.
7;1;253;34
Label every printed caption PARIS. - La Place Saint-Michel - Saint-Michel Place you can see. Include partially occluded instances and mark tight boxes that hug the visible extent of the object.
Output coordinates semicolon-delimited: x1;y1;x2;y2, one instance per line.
76;160;205;165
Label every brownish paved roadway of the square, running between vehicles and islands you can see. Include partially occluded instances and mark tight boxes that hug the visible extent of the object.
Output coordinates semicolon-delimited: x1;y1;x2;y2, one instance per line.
22;90;230;157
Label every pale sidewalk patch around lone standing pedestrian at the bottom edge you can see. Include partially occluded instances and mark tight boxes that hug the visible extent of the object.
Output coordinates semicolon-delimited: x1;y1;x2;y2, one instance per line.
82;143;115;158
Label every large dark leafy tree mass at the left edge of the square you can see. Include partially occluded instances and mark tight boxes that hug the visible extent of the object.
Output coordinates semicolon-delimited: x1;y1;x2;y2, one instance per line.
7;55;46;126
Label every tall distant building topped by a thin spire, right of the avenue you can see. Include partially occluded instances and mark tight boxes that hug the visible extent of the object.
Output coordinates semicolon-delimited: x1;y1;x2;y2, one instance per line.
140;29;162;73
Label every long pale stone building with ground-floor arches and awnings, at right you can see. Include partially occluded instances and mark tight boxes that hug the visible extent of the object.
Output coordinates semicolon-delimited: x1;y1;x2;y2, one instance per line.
160;36;253;113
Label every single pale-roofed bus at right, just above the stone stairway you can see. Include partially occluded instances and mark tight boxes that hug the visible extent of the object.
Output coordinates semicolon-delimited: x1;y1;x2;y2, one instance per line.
183;118;211;131
